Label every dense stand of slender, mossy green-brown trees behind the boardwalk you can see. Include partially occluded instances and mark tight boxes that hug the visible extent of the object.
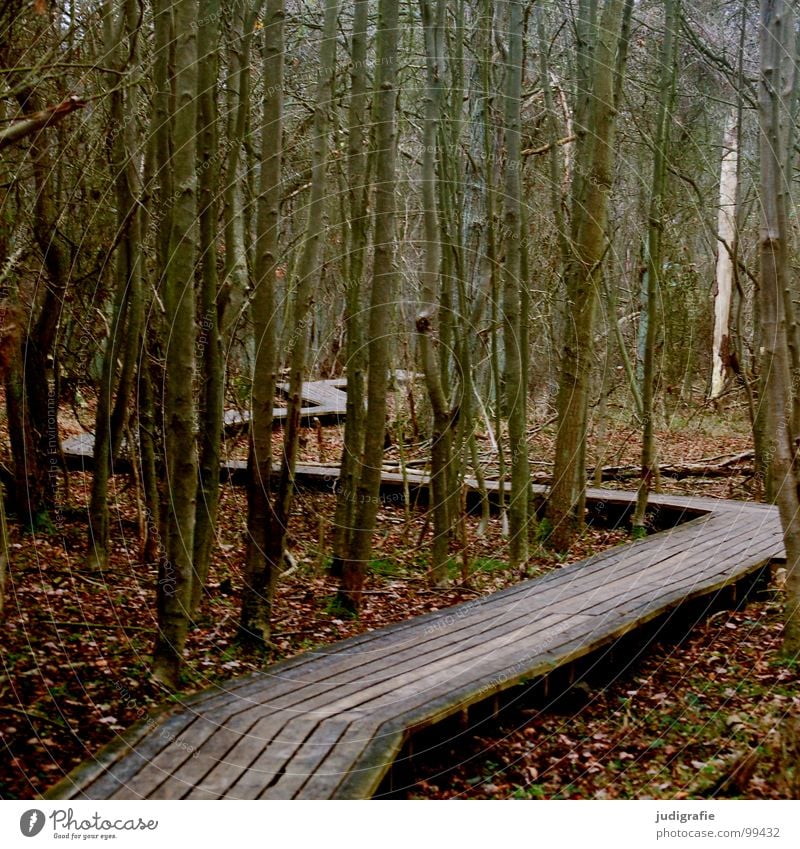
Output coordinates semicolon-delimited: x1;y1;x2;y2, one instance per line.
0;0;800;800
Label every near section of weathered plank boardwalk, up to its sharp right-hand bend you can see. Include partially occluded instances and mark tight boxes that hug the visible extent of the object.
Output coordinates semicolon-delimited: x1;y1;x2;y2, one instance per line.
43;484;783;799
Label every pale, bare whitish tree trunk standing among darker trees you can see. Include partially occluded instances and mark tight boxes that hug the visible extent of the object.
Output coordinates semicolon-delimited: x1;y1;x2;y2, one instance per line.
711;112;739;399
